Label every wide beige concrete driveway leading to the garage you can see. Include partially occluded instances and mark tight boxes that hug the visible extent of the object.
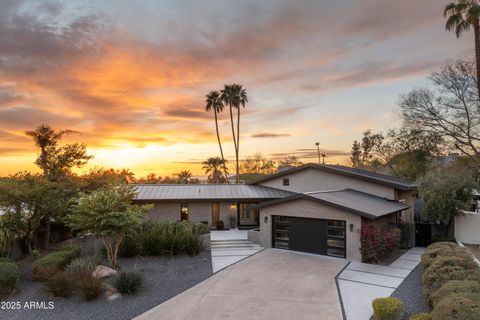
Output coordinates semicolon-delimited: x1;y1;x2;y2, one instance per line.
136;249;347;320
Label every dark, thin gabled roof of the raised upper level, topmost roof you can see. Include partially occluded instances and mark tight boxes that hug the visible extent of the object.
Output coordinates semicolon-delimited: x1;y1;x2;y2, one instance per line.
252;163;417;190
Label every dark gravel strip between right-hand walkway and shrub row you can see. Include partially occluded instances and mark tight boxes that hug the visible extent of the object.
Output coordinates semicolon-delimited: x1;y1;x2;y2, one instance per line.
392;263;430;320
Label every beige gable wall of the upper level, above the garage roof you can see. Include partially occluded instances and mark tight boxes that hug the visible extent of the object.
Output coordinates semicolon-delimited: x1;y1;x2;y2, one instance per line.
259;168;396;199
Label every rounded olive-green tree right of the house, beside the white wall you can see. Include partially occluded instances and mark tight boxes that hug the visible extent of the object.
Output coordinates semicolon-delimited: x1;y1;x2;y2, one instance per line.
418;170;475;238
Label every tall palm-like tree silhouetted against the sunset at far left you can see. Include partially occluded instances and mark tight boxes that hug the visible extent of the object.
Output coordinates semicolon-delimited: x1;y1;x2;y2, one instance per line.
25;124;79;177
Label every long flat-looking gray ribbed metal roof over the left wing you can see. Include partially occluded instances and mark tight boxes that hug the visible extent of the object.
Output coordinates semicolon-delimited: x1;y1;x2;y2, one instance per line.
134;184;294;201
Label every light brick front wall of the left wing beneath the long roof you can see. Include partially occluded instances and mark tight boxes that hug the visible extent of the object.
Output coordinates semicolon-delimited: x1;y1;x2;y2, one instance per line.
147;201;237;228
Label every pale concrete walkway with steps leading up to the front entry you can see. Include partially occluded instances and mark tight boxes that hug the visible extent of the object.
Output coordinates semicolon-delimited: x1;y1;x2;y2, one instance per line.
210;229;263;273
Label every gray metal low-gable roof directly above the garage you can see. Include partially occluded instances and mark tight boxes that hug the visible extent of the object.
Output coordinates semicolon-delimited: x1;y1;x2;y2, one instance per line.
257;189;410;220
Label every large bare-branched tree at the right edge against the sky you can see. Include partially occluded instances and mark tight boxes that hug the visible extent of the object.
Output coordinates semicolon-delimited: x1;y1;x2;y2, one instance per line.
399;60;480;172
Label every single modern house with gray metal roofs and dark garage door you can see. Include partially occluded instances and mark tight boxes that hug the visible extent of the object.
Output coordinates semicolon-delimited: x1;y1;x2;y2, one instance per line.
136;164;416;260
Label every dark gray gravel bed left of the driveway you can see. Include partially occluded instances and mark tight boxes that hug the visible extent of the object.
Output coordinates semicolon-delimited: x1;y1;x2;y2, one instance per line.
0;251;212;320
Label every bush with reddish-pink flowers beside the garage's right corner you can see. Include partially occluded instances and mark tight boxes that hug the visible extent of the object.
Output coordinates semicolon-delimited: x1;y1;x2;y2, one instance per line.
360;226;399;263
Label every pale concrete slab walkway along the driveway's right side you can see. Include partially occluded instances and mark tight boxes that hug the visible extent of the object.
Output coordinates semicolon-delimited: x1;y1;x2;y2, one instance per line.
337;248;424;320
